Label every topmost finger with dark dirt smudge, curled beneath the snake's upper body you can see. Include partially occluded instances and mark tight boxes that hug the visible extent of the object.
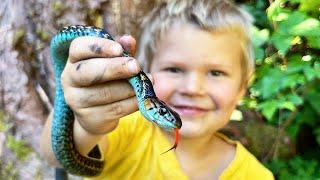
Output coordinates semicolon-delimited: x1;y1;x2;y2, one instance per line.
69;36;123;63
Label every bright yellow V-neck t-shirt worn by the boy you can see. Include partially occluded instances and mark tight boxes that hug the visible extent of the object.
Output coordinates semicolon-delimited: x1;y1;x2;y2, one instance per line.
87;112;274;180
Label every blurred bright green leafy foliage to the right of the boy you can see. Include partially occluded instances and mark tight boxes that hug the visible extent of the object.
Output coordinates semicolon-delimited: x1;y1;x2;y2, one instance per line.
244;0;320;179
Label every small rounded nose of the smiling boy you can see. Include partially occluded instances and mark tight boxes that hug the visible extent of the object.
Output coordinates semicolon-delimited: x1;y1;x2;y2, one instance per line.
180;74;205;95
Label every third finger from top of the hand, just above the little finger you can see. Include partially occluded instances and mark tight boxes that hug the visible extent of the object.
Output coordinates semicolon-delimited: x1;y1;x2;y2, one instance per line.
65;80;135;108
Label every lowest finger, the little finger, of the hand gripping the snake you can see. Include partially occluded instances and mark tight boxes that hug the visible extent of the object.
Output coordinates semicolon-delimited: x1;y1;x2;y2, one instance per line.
75;97;138;134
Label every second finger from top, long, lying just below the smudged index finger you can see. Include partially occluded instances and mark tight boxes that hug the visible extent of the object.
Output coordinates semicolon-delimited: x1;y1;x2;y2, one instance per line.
61;57;140;87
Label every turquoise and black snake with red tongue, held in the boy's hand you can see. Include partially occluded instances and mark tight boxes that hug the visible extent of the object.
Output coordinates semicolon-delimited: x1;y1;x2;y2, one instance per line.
50;25;182;177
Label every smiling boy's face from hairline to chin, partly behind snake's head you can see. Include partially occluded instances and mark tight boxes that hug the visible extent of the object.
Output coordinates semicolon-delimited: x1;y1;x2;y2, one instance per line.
150;24;245;137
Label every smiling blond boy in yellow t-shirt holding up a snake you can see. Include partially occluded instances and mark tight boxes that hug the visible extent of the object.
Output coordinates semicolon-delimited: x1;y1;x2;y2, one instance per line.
41;0;273;180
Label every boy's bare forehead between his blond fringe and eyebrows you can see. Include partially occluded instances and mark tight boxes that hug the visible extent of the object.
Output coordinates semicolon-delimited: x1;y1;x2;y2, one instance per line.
156;24;242;64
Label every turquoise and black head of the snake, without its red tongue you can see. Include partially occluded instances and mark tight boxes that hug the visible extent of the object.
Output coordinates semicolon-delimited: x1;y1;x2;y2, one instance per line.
144;98;182;130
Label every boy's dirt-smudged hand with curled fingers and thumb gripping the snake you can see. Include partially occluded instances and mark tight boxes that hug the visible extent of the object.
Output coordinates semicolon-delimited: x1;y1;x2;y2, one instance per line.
61;35;140;134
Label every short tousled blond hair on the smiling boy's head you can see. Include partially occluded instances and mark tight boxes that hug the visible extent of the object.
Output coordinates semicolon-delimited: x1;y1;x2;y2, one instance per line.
137;0;254;83
